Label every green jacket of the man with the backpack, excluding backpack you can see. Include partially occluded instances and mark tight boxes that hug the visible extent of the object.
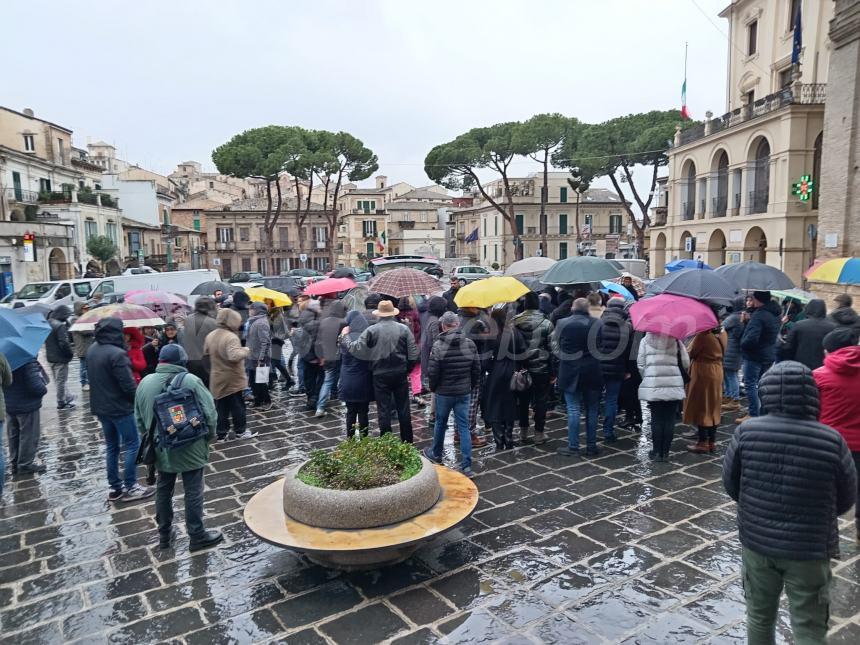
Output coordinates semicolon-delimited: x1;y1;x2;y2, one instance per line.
134;363;218;473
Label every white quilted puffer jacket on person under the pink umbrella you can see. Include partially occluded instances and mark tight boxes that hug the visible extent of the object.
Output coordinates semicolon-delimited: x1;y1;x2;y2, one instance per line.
636;333;690;401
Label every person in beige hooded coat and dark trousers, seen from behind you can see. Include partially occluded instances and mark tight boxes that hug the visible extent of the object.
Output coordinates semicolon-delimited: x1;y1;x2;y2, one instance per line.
203;309;252;441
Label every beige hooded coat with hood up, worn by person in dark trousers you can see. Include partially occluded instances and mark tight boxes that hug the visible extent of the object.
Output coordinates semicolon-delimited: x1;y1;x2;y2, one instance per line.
203;309;251;399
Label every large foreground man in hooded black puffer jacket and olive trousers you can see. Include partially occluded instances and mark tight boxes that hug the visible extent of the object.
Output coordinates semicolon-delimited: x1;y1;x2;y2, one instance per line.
723;361;857;644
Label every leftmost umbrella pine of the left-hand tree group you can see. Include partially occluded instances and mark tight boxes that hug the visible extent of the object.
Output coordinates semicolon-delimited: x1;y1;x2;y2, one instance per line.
212;125;303;273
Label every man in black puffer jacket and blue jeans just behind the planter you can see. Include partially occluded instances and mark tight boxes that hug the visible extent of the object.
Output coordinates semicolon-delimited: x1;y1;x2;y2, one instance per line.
424;311;481;477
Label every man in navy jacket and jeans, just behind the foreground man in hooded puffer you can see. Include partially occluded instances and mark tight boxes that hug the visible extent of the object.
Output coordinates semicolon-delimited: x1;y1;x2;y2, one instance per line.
737;291;782;423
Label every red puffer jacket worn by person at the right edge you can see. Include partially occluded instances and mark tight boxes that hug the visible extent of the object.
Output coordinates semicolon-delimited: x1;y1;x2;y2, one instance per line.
812;346;860;452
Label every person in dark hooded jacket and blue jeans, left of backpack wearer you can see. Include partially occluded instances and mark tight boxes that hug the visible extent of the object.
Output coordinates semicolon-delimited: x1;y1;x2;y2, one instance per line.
86;318;155;502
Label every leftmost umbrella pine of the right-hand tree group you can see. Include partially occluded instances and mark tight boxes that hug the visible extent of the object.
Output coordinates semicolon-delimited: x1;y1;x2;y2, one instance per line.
424;122;522;265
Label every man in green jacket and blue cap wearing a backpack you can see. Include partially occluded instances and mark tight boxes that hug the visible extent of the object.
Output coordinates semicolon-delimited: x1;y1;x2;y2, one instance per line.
134;344;224;551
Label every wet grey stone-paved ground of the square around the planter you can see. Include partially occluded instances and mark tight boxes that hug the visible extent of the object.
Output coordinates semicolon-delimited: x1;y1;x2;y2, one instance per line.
0;360;860;645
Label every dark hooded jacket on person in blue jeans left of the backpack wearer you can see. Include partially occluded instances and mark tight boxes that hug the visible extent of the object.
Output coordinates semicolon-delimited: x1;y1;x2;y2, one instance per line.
86;318;137;417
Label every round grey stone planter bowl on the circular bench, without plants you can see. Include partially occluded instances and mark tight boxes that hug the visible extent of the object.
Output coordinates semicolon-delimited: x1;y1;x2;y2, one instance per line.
284;457;442;529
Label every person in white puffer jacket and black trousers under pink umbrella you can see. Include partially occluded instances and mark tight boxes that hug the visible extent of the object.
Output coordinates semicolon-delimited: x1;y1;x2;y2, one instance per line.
636;332;690;462
